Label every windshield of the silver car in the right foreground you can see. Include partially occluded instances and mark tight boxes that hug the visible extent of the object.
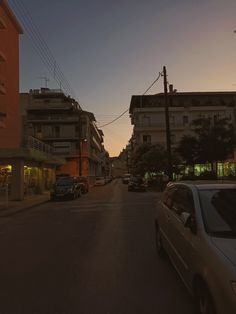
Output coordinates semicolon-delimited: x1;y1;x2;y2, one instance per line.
199;189;236;238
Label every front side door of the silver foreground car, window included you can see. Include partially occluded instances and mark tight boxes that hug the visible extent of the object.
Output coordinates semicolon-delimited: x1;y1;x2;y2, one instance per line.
169;185;198;286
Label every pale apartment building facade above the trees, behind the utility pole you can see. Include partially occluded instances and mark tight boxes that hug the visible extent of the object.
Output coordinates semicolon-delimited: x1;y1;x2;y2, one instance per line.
129;92;236;146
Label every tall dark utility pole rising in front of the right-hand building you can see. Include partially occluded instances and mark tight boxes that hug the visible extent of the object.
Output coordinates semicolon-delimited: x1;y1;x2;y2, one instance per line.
163;66;173;181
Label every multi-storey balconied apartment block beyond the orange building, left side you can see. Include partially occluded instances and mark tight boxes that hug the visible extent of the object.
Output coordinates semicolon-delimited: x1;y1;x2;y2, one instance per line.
21;88;106;184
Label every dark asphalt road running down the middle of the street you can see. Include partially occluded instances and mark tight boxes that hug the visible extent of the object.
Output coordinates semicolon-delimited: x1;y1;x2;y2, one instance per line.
0;180;193;314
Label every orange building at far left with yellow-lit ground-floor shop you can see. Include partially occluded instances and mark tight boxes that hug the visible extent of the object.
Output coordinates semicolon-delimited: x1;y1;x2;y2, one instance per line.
0;0;60;200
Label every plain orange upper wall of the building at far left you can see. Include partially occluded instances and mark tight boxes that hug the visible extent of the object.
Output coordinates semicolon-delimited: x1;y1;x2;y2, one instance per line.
0;1;21;148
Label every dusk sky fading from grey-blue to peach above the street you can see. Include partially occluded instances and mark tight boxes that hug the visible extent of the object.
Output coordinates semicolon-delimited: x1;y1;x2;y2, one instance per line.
9;0;236;156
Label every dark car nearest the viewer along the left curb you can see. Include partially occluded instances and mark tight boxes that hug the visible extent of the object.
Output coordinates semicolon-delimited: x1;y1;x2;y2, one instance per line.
51;177;82;200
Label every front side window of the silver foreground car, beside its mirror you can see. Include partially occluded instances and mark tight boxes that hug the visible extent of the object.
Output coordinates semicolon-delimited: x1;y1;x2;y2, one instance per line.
172;186;194;215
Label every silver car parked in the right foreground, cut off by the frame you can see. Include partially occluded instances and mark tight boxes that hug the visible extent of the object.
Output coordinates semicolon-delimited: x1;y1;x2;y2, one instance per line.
155;182;236;314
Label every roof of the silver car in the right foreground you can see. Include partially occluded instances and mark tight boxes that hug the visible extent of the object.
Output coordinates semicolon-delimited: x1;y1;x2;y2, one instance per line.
168;180;236;190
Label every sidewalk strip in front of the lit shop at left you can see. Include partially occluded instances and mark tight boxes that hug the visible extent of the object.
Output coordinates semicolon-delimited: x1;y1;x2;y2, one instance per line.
0;192;50;217
